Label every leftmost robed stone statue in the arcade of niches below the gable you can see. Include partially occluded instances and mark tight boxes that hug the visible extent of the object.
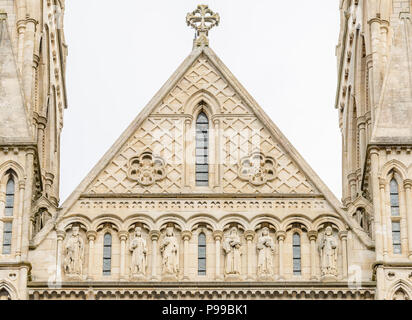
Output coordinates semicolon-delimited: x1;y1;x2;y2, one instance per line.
63;226;84;277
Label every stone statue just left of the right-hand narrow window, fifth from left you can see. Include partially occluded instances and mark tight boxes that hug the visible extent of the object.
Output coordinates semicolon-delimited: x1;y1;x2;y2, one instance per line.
257;227;275;278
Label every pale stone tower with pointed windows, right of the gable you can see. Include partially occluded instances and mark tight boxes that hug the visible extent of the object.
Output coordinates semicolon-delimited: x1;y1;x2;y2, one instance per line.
336;0;412;299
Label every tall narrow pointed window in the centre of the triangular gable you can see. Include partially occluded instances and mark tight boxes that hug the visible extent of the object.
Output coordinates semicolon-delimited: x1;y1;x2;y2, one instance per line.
196;111;209;187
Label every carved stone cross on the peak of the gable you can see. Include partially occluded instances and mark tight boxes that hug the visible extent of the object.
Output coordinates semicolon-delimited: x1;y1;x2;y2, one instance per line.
186;4;220;47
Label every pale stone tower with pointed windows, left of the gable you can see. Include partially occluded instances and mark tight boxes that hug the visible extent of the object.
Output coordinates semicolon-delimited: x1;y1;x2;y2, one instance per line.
0;0;67;299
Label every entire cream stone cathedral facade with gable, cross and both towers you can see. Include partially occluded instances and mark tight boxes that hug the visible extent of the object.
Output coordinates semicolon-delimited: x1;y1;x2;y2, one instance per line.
0;0;412;300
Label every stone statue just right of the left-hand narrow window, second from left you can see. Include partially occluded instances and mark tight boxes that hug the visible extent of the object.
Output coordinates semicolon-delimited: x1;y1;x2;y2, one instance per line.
129;227;147;277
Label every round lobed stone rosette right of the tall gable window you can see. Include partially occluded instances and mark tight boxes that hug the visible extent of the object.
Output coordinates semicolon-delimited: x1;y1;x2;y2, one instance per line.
239;152;276;186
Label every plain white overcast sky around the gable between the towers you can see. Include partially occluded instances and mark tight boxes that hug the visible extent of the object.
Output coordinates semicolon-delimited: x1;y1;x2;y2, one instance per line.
61;0;341;201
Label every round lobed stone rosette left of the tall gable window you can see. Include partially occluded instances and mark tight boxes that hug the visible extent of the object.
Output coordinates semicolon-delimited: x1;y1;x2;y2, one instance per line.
127;152;166;186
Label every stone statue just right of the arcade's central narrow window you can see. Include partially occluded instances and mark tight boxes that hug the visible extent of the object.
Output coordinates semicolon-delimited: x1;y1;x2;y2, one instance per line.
223;227;242;275
